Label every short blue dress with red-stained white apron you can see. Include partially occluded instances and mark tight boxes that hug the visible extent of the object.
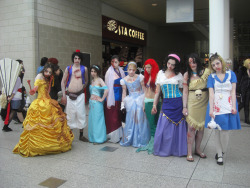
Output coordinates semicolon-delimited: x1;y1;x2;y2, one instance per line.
205;71;241;130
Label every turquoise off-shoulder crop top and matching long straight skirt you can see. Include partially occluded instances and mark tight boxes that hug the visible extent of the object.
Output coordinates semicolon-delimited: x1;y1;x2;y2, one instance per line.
88;85;108;143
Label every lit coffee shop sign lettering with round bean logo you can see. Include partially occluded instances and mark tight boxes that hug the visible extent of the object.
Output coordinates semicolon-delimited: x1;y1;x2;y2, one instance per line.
107;20;145;40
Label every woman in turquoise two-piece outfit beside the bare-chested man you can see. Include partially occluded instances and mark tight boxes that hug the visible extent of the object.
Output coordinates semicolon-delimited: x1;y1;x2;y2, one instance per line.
88;65;108;144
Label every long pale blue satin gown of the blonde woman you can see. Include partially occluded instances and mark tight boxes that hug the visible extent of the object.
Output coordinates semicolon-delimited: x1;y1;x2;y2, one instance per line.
120;76;150;147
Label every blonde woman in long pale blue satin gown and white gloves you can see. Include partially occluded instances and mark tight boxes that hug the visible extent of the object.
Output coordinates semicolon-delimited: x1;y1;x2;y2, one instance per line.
120;61;150;147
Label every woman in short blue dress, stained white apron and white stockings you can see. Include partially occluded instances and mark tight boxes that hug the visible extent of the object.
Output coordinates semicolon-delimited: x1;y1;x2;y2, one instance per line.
205;53;241;165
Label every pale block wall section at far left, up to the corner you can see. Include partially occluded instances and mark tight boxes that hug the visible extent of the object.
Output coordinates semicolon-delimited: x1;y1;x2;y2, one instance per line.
0;0;35;83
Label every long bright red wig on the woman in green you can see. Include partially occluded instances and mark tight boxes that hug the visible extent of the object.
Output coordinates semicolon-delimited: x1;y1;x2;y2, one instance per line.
144;59;159;90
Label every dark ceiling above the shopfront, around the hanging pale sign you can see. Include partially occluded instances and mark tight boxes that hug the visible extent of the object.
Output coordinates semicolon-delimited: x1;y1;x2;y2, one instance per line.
101;0;250;27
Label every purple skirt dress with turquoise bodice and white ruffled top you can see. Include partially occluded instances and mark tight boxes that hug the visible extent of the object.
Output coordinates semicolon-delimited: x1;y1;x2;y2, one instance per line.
154;71;187;157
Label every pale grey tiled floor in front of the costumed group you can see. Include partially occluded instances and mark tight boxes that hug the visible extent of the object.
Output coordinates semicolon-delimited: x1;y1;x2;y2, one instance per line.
0;121;250;188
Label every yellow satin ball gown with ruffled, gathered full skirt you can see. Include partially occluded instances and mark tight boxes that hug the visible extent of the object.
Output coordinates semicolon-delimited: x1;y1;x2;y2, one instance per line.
13;79;74;157
